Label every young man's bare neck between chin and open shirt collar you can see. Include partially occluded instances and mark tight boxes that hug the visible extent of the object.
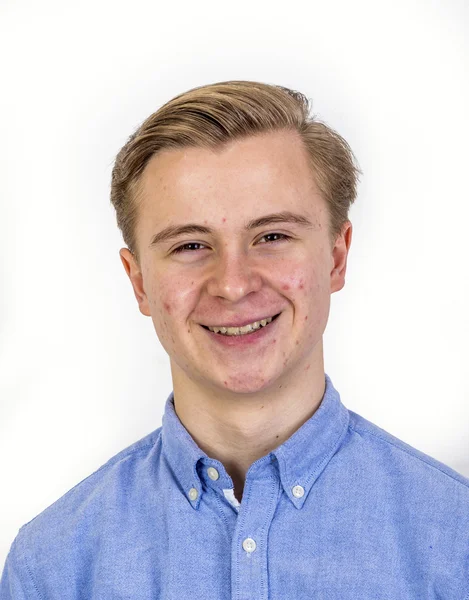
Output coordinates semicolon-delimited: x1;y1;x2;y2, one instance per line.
171;341;325;501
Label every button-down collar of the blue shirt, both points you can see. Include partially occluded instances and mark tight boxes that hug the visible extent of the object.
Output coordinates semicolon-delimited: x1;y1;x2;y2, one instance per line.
162;374;349;509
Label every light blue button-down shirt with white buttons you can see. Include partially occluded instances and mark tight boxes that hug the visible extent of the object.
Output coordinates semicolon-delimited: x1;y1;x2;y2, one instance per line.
0;375;469;600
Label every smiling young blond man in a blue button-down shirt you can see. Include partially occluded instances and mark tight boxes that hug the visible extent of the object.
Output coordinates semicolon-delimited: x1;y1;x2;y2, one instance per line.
1;82;469;600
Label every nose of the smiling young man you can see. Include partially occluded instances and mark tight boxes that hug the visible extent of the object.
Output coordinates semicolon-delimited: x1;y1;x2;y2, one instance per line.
207;253;262;302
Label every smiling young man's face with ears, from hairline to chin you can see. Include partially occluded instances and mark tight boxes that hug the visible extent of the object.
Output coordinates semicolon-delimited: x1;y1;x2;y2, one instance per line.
120;132;351;394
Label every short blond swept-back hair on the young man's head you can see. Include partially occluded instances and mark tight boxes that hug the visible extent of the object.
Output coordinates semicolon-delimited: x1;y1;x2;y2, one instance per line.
111;81;361;264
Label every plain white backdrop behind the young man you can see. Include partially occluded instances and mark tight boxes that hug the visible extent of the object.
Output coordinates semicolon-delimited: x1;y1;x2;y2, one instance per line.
0;0;469;568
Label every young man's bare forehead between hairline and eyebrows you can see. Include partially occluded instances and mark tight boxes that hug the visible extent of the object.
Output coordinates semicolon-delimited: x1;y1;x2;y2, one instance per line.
134;131;325;227
